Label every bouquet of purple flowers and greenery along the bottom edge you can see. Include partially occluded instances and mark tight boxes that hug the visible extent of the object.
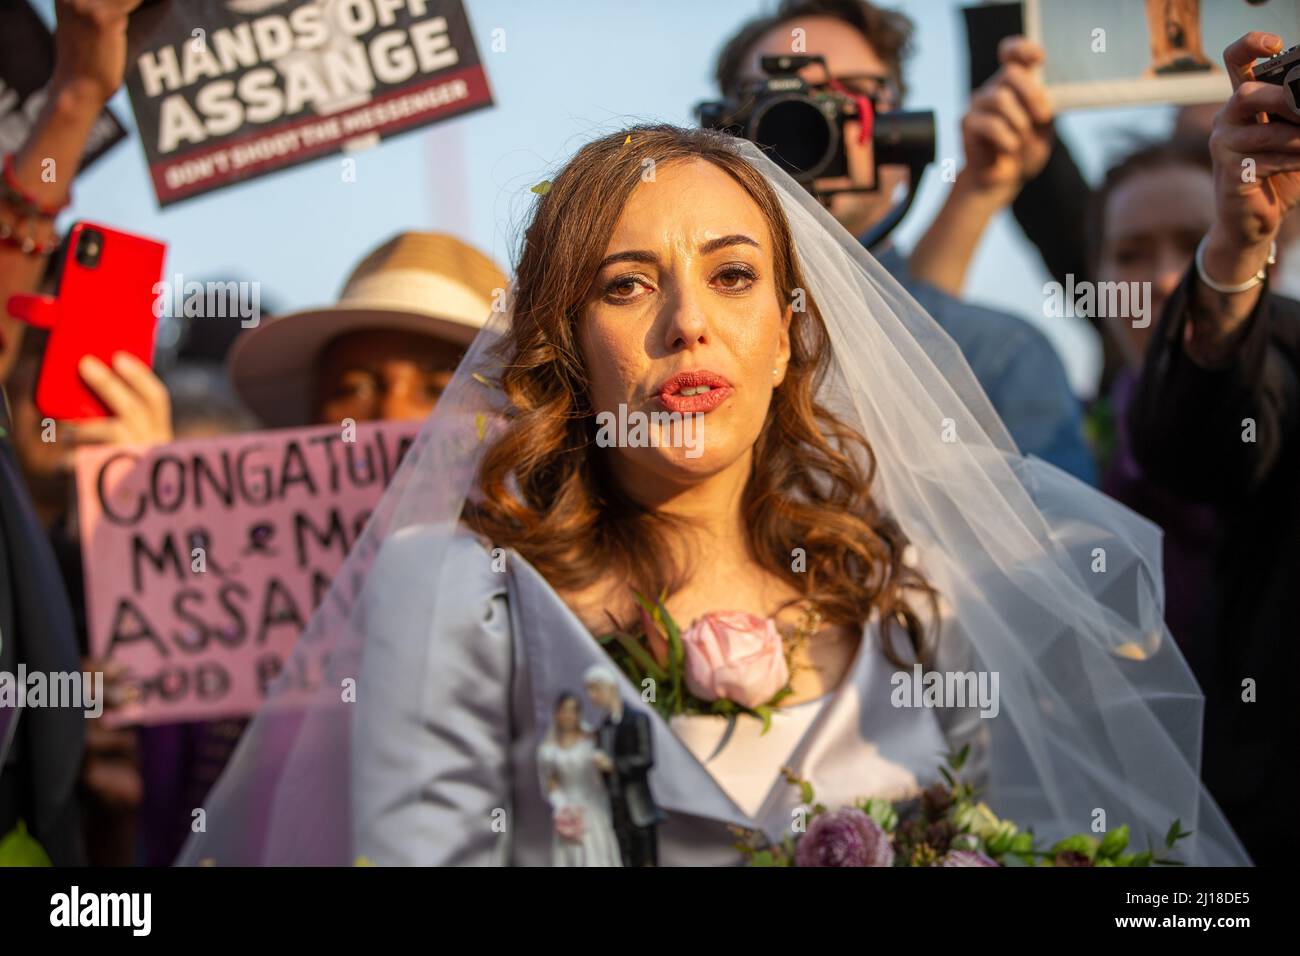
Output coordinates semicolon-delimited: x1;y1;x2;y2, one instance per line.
732;747;1190;866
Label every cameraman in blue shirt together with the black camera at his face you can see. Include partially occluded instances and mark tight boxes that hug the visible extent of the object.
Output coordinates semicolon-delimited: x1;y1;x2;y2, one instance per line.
701;0;1096;483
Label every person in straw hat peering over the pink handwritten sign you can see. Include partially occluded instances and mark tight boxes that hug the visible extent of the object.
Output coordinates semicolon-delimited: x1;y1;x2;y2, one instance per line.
230;232;506;428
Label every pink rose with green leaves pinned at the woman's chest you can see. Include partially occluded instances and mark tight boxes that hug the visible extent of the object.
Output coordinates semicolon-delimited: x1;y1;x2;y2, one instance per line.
597;589;822;732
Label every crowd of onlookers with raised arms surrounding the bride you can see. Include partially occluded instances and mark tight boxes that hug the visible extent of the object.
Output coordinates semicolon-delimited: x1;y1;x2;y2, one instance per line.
0;0;1300;865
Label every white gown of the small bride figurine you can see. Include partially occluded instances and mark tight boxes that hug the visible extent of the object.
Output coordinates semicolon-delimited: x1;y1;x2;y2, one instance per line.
537;735;623;866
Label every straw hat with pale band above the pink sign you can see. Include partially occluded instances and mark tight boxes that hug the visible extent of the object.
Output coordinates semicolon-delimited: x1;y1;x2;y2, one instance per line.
229;233;506;428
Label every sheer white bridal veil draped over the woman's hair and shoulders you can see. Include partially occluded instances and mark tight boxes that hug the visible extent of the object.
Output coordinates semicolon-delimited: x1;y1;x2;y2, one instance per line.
179;139;1248;866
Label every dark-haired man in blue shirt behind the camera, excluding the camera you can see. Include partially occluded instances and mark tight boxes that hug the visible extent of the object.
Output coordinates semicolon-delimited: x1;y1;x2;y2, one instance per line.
714;0;1096;483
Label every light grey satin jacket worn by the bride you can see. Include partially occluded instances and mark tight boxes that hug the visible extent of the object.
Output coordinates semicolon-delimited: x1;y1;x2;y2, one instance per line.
351;529;980;866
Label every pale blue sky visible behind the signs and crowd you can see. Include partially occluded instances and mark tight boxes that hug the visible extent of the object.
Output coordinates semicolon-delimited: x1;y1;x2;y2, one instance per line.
38;0;1171;392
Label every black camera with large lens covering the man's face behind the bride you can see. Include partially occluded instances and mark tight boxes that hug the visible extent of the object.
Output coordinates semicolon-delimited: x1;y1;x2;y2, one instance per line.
696;55;935;195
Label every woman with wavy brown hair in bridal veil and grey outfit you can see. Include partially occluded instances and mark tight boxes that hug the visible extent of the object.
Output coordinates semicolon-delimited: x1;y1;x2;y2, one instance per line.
181;126;1248;865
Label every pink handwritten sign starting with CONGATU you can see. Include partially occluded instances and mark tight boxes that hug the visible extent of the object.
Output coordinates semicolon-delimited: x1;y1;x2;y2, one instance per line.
77;421;419;726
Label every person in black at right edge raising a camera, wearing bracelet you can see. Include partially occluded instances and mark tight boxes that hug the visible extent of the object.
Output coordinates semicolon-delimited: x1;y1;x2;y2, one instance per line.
1128;33;1300;864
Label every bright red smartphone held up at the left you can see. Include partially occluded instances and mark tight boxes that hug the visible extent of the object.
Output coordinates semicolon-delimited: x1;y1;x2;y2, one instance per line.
8;222;166;419
